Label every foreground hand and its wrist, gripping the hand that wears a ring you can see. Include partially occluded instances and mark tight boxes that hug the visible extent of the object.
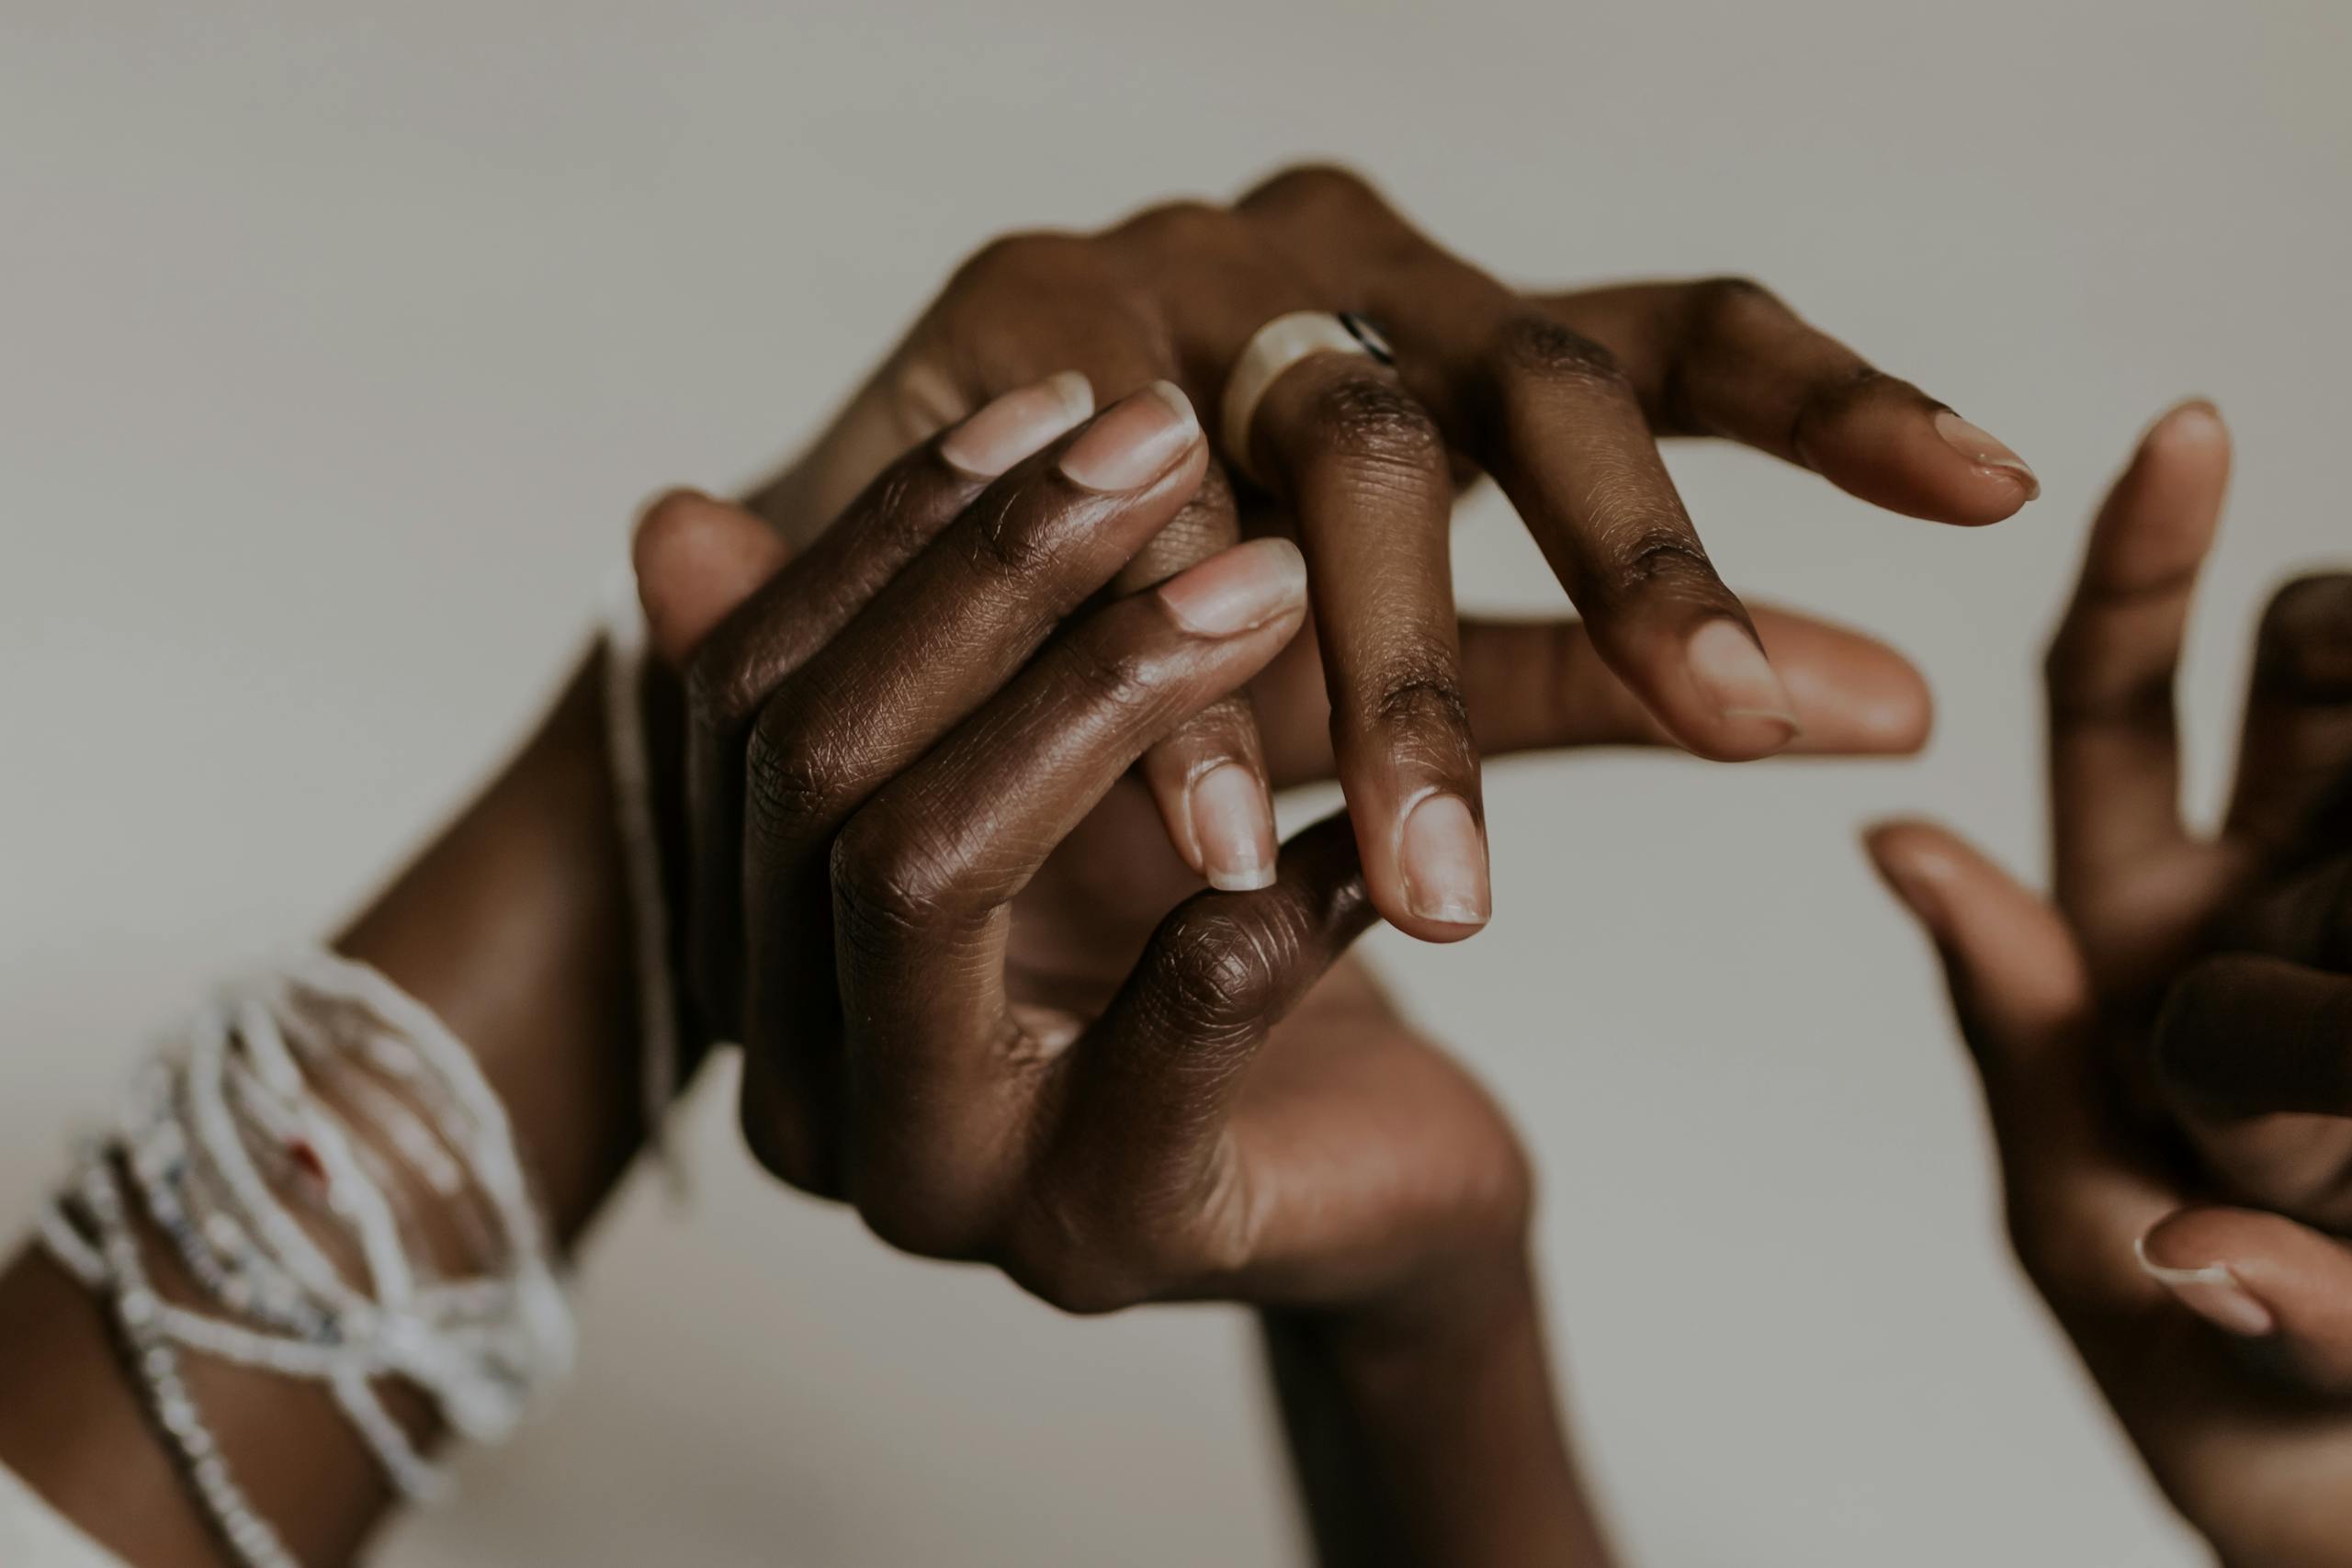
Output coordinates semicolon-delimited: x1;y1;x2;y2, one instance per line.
638;355;1927;1563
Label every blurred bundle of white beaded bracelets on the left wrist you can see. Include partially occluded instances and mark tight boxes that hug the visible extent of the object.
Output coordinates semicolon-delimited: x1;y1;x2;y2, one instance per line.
42;952;574;1568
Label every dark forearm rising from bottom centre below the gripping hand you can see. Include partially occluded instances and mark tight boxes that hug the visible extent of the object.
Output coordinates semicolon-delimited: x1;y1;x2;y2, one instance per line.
1261;1253;1611;1568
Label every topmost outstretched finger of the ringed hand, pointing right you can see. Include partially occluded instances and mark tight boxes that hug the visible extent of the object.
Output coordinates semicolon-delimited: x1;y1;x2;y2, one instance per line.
1541;277;2041;525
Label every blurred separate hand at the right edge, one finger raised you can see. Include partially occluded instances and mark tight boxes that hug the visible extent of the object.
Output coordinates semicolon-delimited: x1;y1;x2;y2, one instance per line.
1870;404;2352;1565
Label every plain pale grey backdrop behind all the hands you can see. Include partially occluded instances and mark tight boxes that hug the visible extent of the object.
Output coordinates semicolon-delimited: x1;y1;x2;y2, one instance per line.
0;0;2352;1568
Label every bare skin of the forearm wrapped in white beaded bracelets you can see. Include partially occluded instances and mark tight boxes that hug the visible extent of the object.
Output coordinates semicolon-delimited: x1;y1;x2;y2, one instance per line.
0;644;642;1565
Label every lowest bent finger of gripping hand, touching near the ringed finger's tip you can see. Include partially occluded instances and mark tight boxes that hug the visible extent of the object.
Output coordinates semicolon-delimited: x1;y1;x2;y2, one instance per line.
1040;816;1374;1303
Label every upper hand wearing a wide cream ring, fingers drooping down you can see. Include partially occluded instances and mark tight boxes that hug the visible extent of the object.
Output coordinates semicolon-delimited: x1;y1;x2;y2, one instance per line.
755;169;2034;941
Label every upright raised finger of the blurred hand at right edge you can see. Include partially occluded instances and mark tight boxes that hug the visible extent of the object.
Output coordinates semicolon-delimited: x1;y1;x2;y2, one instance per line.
2046;402;2230;908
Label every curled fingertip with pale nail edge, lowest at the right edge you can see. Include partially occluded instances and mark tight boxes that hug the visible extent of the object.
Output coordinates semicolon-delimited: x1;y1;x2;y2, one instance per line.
2138;1208;2352;1394
